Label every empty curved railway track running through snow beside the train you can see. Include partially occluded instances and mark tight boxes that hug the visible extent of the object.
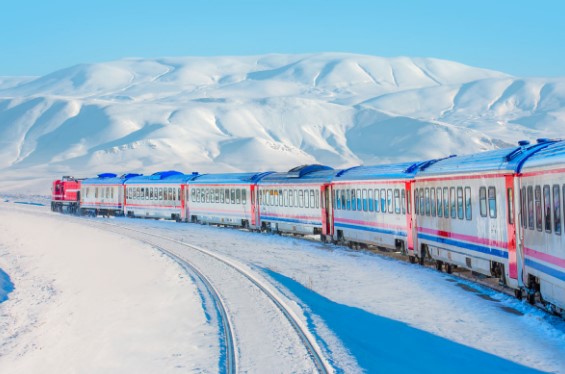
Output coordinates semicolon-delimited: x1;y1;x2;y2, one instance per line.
83;218;334;373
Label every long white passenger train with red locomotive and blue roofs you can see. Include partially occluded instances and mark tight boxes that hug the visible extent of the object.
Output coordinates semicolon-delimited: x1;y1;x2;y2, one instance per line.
51;139;565;318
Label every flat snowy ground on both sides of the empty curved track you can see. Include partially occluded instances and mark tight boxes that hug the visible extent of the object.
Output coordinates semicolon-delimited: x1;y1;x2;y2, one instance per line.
0;196;565;374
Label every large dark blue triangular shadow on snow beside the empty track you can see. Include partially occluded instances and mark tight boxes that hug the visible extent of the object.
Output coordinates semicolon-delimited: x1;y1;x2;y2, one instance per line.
264;269;541;374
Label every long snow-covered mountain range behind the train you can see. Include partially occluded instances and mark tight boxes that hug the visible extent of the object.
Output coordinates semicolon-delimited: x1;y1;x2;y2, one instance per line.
0;53;565;188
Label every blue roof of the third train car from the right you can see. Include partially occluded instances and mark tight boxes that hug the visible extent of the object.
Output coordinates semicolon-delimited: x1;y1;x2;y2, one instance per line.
334;159;439;182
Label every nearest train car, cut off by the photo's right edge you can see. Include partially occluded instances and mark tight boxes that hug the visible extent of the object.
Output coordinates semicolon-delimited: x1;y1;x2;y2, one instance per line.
517;141;565;310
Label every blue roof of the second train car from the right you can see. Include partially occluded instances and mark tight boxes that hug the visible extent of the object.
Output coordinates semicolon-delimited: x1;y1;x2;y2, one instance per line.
416;139;555;178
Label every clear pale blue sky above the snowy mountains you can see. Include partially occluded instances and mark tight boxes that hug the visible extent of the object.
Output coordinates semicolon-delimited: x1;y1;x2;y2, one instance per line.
0;0;565;77
